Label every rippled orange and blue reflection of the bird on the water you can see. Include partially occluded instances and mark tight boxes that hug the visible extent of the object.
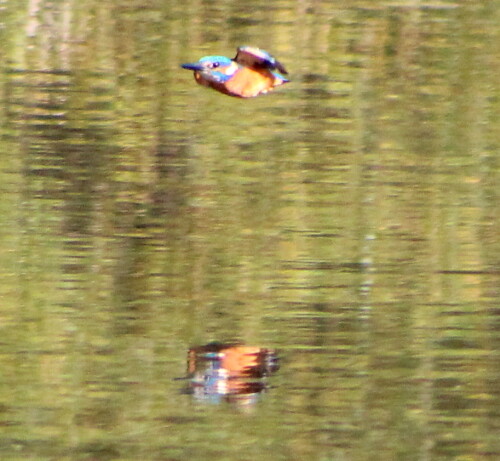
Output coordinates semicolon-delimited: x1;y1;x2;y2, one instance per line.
187;342;279;406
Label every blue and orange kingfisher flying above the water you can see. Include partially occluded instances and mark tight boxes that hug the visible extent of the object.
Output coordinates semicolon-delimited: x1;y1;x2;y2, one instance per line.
181;46;290;98
